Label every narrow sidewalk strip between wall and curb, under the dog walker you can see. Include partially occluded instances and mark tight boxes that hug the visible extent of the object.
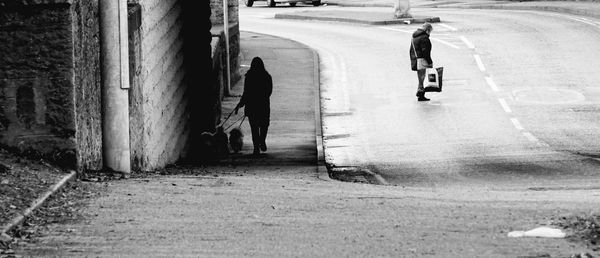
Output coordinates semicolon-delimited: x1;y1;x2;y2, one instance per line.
216;33;320;170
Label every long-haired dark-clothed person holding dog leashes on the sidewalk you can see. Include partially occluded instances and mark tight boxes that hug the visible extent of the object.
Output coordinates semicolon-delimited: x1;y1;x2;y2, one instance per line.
235;57;273;155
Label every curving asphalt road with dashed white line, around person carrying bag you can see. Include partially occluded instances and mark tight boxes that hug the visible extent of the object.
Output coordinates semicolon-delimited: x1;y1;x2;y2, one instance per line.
240;5;600;189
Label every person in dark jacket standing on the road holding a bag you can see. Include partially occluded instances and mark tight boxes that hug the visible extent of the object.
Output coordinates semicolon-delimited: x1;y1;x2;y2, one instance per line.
409;23;433;101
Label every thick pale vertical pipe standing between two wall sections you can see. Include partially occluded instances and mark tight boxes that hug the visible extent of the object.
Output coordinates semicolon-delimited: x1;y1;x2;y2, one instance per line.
99;0;131;176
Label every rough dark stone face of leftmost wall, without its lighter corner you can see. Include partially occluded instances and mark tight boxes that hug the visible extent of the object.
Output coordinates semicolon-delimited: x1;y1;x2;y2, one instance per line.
0;4;76;168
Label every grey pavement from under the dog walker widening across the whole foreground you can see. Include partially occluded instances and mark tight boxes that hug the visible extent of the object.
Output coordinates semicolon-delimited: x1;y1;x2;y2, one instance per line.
16;32;595;257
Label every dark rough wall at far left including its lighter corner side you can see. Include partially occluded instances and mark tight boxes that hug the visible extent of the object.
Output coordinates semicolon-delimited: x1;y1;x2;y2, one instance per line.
0;0;102;170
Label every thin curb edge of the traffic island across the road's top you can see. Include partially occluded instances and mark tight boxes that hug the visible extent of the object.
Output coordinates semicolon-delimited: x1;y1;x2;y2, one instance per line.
274;13;441;25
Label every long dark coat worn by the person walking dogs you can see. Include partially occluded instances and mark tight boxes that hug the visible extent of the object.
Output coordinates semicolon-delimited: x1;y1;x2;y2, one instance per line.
240;57;273;125
